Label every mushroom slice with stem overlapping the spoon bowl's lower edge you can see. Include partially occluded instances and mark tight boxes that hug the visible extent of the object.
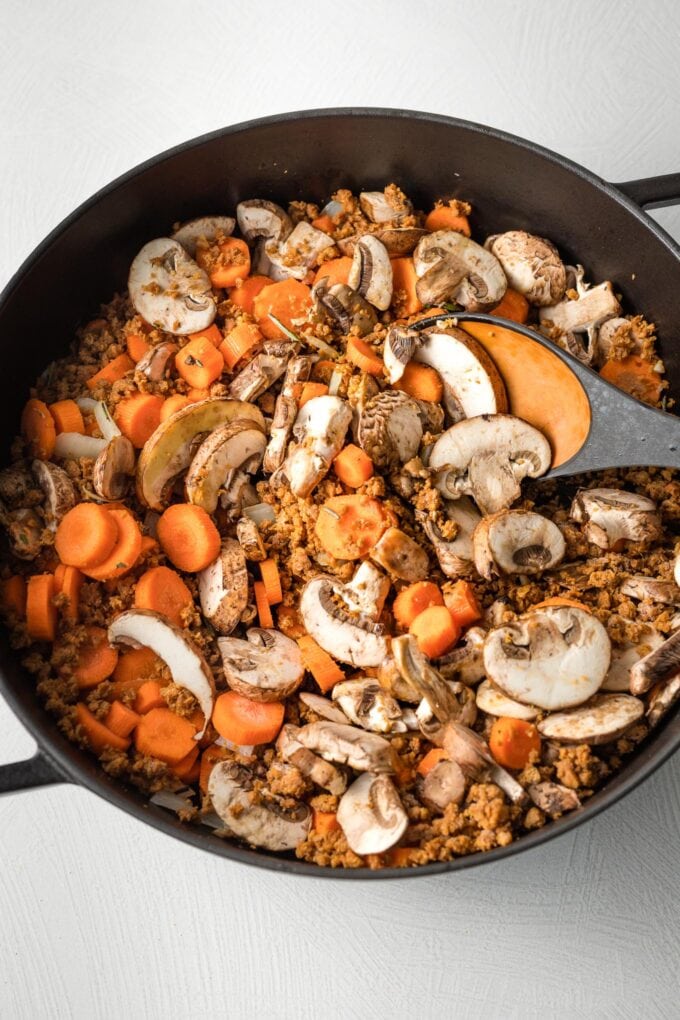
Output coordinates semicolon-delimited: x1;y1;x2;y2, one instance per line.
429;414;552;513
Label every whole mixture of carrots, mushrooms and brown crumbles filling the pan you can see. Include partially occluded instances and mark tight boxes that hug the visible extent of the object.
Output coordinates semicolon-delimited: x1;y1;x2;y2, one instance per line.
0;184;680;868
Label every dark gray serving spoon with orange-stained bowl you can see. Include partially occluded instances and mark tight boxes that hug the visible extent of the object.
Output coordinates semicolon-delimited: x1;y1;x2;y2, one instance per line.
415;312;680;478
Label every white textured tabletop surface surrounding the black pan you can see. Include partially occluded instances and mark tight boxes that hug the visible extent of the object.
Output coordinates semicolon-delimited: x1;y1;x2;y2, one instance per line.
0;0;680;1020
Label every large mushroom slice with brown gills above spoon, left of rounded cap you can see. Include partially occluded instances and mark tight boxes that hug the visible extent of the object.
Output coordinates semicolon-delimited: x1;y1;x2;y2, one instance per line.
413;231;508;312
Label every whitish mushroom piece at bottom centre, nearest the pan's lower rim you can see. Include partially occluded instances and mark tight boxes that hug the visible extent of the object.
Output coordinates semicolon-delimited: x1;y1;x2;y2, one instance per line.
337;772;409;854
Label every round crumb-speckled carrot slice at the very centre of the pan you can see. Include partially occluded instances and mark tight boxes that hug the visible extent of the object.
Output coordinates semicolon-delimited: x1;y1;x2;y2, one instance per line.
314;494;389;560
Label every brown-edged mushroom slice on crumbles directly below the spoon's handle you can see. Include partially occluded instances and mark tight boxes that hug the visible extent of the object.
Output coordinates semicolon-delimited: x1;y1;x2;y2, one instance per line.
571;489;662;549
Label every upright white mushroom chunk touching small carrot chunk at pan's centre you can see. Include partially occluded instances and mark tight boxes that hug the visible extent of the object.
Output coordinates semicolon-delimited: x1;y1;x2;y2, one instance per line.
283;396;352;499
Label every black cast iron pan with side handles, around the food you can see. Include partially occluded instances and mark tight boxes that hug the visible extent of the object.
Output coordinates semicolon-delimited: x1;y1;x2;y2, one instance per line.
0;109;680;878
